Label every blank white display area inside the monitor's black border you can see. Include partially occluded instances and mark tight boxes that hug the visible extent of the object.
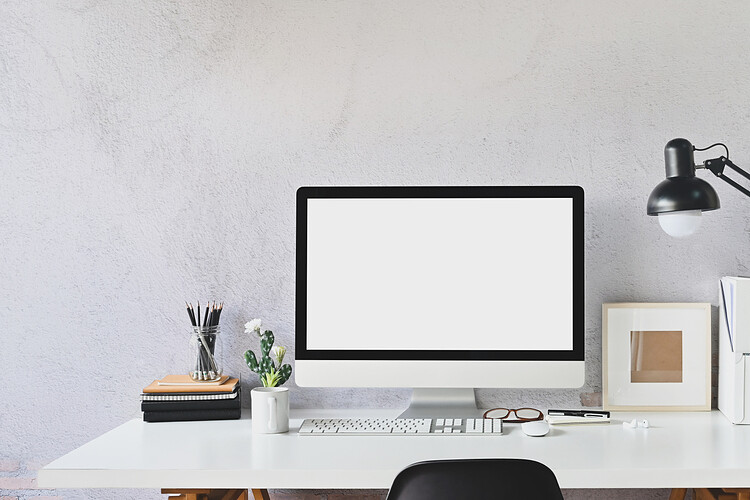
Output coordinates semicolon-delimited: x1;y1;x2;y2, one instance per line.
307;198;573;351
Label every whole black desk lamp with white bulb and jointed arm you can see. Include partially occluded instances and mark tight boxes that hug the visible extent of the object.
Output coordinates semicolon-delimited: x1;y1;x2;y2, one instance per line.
646;139;750;238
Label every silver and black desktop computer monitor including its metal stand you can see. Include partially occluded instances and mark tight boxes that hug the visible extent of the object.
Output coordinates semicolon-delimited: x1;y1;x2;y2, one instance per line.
295;186;584;416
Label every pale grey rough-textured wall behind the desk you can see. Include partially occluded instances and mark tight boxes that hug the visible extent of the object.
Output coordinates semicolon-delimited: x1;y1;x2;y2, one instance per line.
0;0;750;499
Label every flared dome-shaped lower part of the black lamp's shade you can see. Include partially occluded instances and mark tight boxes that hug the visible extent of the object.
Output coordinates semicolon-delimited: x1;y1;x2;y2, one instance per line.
646;177;721;215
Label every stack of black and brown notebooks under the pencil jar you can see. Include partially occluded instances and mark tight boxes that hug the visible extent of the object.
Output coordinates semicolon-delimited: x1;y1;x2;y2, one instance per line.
141;375;240;422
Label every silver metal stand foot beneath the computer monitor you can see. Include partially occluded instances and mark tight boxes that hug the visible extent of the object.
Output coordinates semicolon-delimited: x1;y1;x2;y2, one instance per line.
398;388;482;418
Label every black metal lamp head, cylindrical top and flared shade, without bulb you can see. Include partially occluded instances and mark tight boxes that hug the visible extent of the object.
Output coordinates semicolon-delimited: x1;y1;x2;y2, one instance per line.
646;139;720;215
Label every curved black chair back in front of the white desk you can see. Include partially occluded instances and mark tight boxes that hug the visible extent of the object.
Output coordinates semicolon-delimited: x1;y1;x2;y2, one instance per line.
386;458;563;500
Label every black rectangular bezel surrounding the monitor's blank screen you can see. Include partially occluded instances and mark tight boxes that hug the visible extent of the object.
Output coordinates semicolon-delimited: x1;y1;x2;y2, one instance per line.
295;186;585;361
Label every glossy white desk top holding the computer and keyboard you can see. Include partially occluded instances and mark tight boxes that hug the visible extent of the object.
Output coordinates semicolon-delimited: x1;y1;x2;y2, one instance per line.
38;410;750;489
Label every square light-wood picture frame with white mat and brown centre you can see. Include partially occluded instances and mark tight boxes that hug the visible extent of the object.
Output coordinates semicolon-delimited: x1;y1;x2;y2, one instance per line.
602;303;711;411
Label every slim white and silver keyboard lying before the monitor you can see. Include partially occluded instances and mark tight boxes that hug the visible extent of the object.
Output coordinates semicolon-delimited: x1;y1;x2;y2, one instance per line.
299;418;503;436
